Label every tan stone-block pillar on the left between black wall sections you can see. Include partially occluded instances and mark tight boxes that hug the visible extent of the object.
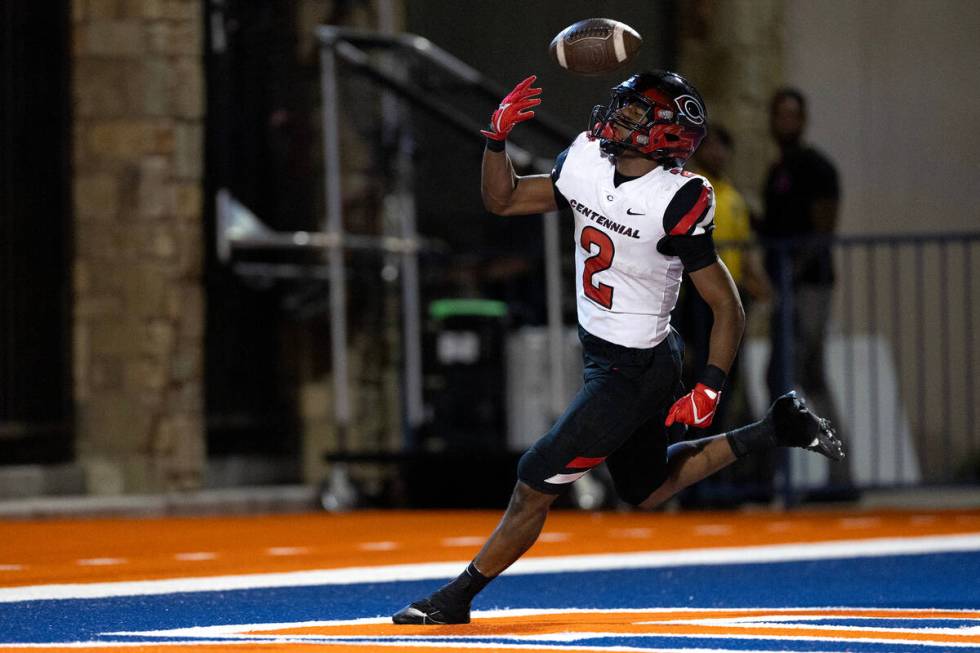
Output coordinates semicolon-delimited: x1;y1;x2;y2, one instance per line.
72;0;205;494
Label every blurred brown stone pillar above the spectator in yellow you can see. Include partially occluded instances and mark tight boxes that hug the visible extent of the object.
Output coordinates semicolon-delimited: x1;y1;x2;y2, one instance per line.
678;0;785;209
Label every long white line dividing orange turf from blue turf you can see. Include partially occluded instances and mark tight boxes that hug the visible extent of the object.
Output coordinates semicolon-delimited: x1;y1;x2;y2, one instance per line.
0;533;980;603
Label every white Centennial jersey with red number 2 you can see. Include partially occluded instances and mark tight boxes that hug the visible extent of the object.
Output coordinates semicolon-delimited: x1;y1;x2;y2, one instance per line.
553;133;715;349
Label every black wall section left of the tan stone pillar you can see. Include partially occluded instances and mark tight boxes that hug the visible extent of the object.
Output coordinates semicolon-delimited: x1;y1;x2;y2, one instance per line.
0;0;71;464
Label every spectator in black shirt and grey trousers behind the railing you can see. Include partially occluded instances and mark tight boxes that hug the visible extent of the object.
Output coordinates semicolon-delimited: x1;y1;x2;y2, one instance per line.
756;88;854;499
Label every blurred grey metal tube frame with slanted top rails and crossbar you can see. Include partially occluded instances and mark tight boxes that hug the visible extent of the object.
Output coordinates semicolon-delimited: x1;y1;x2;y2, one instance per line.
216;26;573;506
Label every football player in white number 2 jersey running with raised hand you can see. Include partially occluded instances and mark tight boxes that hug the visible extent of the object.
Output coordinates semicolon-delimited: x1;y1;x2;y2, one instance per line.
393;71;844;624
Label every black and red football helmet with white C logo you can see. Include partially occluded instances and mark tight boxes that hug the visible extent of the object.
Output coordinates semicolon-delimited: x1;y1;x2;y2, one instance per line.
590;70;708;166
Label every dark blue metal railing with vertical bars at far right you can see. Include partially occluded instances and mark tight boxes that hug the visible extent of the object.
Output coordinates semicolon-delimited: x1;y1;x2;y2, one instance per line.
747;233;980;488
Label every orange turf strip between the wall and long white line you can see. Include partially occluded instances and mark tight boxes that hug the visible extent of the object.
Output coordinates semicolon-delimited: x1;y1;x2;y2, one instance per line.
0;510;980;588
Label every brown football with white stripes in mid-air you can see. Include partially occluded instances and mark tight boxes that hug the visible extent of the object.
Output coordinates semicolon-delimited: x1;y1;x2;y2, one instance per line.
548;18;643;75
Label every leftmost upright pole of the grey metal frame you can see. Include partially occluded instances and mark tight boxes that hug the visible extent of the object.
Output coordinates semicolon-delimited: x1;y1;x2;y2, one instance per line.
320;44;350;432
